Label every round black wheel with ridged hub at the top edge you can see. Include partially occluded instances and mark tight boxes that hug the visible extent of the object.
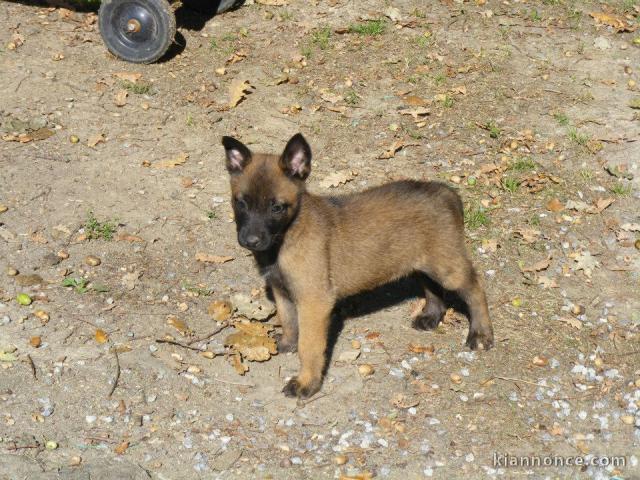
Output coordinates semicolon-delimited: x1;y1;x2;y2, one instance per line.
98;0;176;63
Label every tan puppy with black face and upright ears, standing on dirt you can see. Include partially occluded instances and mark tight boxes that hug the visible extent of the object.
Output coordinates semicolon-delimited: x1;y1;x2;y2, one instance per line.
222;134;493;398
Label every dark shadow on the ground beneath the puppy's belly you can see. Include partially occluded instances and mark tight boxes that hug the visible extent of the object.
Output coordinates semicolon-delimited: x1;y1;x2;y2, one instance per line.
326;273;469;368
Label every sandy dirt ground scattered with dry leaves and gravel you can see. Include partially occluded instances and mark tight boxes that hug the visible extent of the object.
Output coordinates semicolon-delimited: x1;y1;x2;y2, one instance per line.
0;0;640;480
